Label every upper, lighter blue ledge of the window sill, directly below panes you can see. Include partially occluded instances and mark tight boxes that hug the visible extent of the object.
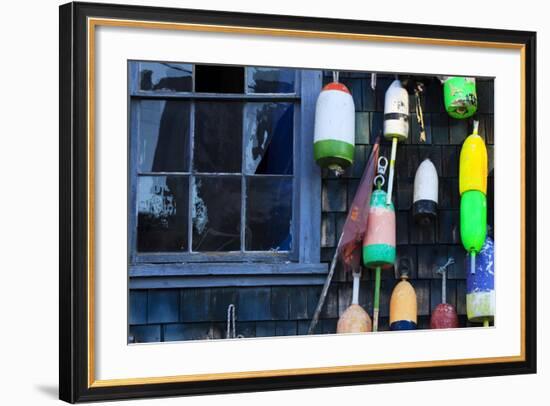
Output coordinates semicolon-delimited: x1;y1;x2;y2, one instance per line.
129;263;327;278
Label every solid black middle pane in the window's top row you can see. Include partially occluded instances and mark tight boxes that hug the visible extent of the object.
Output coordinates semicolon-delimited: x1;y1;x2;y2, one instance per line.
195;65;244;93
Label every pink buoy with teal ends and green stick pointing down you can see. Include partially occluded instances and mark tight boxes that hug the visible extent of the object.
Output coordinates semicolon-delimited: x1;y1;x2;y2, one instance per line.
363;189;396;331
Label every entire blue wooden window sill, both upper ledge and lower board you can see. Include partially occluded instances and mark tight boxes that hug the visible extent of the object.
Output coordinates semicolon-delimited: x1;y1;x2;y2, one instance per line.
129;262;328;289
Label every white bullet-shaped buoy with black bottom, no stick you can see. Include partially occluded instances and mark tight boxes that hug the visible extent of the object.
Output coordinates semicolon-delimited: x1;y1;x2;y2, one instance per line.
412;159;439;224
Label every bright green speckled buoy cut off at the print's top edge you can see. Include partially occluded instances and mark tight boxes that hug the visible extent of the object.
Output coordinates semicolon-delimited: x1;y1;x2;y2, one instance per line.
443;76;477;119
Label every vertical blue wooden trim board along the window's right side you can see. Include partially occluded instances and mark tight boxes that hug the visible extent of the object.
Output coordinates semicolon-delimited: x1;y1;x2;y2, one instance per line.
296;70;322;263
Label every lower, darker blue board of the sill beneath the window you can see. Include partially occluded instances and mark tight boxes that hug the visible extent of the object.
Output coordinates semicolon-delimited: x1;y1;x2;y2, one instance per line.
128;274;326;289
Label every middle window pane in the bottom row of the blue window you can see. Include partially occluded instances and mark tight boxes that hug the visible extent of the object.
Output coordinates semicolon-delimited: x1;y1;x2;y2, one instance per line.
192;176;241;251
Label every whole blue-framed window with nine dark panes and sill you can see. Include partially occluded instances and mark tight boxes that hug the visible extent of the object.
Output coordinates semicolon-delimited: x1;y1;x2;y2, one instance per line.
128;61;326;287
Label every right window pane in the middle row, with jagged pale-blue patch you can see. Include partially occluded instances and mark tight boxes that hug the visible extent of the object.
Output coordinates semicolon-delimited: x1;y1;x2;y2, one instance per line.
245;103;294;175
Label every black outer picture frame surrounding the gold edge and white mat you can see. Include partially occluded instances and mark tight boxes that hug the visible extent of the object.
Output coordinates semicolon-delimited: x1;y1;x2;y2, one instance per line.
59;3;537;403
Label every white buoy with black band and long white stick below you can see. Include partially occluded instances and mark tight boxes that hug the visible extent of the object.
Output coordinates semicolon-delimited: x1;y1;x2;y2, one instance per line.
384;79;409;205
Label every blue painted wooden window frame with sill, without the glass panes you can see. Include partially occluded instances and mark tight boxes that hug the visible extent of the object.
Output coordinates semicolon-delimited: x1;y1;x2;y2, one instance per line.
128;61;327;289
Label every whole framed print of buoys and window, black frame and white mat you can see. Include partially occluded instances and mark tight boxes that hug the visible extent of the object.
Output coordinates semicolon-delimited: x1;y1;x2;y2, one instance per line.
60;3;537;403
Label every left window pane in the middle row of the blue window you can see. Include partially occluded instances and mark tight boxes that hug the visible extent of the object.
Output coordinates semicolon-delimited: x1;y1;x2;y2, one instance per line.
138;100;190;172
